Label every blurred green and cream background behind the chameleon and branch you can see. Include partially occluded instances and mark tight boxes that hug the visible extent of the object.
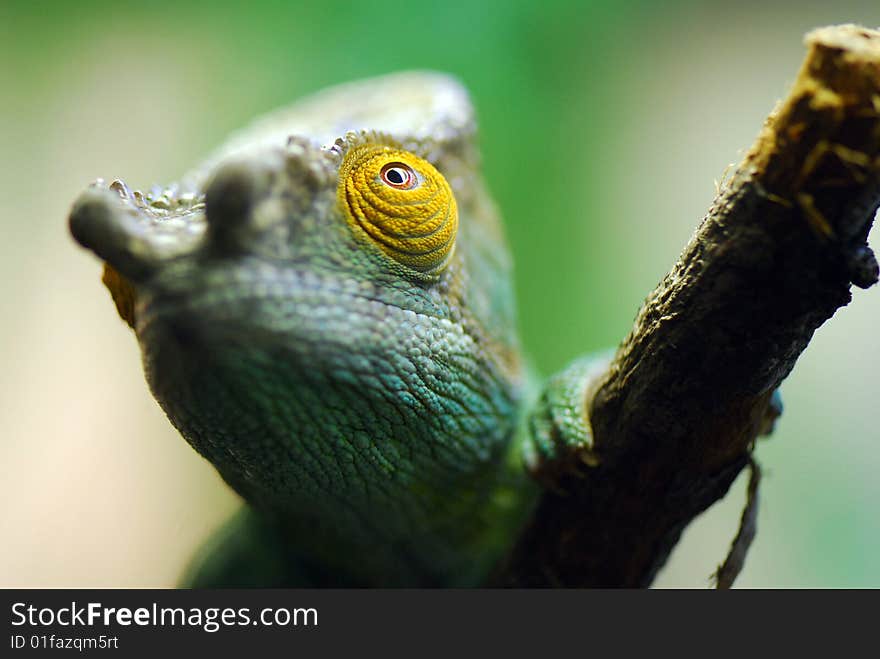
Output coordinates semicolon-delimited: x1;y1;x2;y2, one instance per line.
0;0;880;587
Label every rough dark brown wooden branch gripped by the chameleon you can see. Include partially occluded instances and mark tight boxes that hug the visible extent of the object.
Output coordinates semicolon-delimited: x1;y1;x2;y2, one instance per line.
499;26;880;586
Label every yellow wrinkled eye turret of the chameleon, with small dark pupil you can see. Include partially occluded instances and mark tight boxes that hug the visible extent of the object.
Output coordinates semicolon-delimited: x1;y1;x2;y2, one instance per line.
337;144;458;276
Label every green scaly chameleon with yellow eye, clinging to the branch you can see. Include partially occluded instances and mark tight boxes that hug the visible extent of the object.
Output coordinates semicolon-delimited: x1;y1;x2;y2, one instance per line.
70;73;590;586
